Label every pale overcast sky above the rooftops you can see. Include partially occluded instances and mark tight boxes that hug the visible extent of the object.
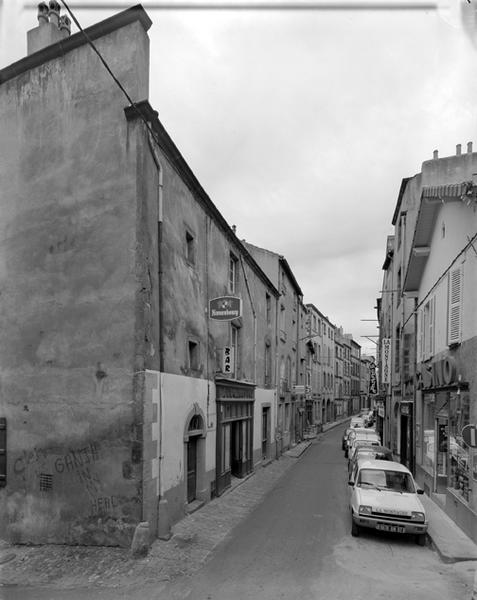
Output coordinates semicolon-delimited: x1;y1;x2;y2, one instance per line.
0;0;477;354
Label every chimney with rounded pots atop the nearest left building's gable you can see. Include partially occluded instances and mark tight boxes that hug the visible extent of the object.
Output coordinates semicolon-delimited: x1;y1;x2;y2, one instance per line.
27;0;71;54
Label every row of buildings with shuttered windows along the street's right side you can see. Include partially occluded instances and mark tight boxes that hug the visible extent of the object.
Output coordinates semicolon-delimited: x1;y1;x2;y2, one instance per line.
376;142;477;542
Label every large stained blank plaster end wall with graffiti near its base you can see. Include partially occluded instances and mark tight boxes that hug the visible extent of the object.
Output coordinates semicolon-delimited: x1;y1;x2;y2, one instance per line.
0;17;148;544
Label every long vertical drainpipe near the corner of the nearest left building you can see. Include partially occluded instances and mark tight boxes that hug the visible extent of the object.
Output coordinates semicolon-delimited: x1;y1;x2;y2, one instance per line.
148;133;171;540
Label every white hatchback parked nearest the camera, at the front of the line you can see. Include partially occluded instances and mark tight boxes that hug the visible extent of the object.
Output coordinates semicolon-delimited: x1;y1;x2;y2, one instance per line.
348;460;428;545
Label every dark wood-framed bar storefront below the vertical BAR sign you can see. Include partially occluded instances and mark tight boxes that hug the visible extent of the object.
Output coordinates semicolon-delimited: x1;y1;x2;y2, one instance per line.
215;379;255;496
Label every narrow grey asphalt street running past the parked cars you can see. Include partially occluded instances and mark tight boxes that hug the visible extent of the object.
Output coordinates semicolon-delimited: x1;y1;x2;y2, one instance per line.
2;426;476;600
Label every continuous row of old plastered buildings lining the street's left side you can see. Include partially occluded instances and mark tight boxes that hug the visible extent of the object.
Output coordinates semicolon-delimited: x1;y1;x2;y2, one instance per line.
0;1;374;545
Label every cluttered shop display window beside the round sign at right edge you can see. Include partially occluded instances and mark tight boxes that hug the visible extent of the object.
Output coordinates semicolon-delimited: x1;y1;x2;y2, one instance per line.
449;394;471;502
